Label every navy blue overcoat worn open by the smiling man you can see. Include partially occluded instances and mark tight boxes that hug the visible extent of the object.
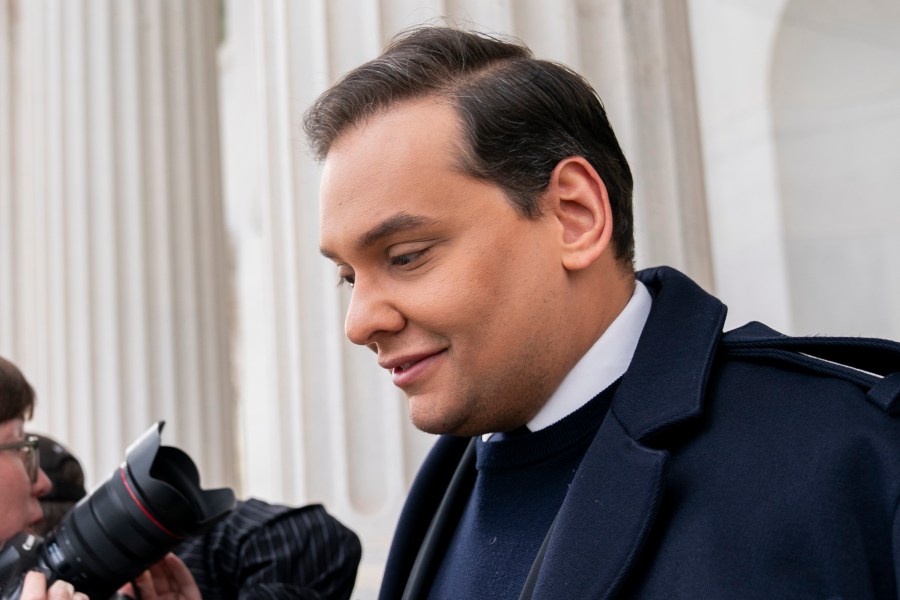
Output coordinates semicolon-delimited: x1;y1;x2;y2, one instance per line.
380;267;900;600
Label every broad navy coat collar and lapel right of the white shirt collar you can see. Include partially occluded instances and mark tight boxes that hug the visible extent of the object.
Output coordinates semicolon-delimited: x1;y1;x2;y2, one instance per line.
534;268;725;599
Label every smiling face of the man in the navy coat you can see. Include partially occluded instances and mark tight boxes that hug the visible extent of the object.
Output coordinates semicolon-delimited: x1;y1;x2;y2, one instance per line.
320;100;571;435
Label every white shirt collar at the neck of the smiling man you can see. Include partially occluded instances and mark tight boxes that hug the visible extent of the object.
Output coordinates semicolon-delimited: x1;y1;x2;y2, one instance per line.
482;281;652;440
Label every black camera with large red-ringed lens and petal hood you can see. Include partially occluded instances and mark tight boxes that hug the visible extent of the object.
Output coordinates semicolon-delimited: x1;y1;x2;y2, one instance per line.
0;421;235;600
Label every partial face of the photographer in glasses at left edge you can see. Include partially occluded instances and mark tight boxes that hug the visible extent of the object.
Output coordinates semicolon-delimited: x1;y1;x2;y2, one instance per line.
0;419;50;544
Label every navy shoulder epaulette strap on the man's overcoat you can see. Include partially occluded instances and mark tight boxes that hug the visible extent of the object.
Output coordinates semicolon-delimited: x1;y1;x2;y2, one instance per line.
719;322;900;416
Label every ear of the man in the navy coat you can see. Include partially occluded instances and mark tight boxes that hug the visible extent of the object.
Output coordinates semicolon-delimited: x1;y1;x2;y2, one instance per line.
548;156;613;271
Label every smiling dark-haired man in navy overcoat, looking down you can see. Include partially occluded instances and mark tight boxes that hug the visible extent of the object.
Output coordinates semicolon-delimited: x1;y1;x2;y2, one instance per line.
304;27;900;599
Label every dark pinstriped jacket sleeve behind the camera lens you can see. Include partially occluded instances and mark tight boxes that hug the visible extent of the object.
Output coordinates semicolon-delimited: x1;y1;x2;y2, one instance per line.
175;499;362;600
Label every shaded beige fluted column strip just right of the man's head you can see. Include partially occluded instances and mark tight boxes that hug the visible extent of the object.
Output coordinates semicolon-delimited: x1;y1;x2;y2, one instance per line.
621;0;715;292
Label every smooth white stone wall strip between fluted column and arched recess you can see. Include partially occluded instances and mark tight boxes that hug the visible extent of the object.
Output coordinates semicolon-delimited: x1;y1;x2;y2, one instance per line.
688;0;792;333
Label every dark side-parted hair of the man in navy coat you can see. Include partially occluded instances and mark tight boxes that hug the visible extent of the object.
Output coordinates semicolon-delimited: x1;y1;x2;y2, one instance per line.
303;26;634;266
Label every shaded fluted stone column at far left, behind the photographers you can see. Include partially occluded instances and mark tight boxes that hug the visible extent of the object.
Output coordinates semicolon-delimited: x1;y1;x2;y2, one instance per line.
0;0;237;492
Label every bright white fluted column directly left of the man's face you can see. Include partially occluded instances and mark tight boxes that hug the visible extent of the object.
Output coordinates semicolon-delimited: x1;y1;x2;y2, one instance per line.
220;0;431;598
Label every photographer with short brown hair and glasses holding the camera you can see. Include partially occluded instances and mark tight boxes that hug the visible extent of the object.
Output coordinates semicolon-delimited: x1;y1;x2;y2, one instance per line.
0;357;200;600
